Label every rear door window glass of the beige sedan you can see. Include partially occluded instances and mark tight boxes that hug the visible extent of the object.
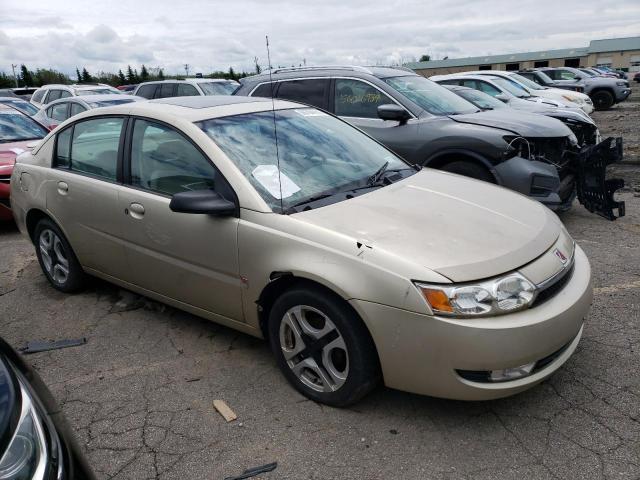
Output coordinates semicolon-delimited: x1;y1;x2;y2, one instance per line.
71;118;124;181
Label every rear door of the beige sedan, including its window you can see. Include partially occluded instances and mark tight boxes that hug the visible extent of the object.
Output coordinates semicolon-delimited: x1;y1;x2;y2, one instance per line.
46;116;128;280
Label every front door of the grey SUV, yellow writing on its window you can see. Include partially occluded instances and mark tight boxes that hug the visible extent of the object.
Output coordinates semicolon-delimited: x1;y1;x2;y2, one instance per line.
333;78;418;159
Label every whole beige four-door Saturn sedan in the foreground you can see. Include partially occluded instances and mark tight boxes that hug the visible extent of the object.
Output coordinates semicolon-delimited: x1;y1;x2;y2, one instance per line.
11;96;592;406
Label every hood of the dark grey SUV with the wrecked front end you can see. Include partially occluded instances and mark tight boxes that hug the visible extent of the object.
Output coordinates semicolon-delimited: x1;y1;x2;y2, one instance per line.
449;109;571;138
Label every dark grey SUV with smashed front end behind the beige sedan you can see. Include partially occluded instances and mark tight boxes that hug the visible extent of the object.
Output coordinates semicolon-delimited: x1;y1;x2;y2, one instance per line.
234;66;624;220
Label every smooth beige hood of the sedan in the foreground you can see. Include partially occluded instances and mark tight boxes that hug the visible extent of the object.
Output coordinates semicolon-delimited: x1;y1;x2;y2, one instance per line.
292;168;561;282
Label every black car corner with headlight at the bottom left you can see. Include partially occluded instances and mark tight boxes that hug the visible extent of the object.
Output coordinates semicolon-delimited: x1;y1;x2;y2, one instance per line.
0;338;95;480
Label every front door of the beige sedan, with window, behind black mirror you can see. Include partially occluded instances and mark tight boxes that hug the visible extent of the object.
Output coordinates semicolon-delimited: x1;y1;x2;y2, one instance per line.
120;119;243;320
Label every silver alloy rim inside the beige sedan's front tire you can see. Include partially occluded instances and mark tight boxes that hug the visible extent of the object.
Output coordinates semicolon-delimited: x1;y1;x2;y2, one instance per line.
279;305;349;392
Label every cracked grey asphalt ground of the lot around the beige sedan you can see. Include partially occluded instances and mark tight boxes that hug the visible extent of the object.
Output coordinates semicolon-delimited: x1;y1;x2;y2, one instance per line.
0;95;640;480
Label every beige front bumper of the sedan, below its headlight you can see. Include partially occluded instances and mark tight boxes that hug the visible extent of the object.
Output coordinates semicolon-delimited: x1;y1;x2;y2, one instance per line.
351;246;593;400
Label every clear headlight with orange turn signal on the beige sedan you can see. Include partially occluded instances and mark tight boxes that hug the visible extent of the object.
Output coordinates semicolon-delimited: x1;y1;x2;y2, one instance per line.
415;273;536;317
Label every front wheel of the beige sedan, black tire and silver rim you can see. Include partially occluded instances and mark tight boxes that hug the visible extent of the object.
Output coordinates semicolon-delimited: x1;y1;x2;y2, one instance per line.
269;286;380;407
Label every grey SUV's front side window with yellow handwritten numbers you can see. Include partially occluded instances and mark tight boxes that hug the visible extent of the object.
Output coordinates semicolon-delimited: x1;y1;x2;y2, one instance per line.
335;78;395;118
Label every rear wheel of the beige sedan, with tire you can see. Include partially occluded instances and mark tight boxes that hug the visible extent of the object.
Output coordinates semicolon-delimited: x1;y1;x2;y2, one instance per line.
34;218;86;293
